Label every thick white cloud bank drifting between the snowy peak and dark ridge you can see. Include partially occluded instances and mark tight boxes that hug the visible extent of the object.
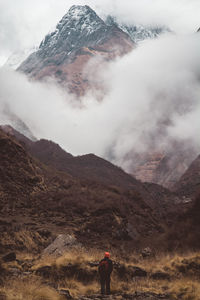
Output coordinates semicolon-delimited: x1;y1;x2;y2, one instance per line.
0;34;200;170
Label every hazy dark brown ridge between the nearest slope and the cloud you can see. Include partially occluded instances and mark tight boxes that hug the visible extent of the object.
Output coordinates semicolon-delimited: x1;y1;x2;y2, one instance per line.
2;126;181;218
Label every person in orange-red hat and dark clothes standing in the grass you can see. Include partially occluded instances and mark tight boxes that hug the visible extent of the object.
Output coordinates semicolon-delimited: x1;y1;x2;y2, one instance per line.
98;252;113;295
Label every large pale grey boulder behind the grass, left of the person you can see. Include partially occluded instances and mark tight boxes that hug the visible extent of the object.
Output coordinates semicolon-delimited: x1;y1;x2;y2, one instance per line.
43;234;81;256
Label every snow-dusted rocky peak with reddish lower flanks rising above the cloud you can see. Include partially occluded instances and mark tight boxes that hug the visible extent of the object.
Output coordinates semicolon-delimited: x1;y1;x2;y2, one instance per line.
18;5;133;95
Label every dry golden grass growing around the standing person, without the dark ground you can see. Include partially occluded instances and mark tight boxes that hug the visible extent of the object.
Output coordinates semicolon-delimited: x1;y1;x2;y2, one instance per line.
1;249;200;300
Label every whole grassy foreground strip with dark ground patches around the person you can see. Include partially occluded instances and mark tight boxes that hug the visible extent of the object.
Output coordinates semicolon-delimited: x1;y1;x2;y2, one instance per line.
0;250;200;300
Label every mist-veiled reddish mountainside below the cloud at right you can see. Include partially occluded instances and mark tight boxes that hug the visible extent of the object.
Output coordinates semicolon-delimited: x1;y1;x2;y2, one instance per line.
131;141;197;188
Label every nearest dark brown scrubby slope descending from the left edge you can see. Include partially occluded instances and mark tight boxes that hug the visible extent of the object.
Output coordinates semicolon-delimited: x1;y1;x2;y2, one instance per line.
0;130;167;251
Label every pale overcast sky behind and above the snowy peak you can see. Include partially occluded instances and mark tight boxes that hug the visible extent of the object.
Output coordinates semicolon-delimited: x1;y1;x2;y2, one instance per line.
0;0;200;65
